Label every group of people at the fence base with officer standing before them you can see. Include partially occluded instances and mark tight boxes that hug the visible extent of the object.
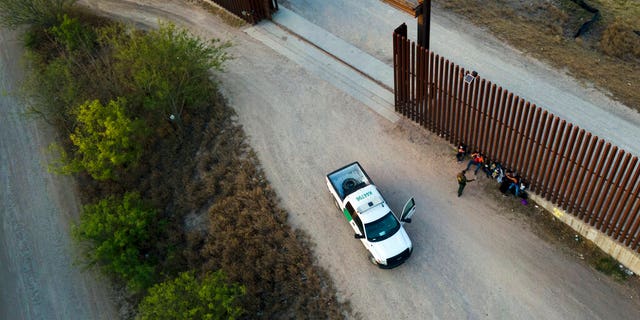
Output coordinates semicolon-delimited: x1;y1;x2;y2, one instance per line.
456;144;528;203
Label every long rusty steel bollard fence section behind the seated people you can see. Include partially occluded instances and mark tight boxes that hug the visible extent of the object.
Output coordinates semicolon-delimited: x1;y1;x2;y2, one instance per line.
393;26;640;252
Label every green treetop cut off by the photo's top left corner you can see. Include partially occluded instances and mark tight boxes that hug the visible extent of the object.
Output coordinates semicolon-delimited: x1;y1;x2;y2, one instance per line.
0;0;76;29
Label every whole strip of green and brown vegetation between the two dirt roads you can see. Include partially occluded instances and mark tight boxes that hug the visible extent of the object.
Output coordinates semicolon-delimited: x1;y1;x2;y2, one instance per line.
0;0;350;319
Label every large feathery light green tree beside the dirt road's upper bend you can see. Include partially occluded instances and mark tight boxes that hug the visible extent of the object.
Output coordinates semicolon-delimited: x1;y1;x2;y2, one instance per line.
106;23;230;123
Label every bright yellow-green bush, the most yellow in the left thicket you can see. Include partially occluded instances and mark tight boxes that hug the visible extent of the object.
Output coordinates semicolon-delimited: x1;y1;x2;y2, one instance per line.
67;98;148;180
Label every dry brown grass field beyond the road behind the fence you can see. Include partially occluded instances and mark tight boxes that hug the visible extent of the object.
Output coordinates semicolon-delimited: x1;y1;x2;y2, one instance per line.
434;0;640;111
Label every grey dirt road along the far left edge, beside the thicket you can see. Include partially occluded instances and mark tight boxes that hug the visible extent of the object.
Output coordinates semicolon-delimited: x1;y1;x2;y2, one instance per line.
0;30;117;319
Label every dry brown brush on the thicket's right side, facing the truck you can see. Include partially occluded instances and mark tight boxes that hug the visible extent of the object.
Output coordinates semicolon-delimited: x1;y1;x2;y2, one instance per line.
185;104;349;319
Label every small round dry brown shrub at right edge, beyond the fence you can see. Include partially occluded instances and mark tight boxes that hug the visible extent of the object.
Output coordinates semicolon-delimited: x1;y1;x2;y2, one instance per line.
600;20;640;60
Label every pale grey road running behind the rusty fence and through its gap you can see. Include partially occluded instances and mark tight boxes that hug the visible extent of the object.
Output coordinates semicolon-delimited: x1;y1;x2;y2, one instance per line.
278;0;640;156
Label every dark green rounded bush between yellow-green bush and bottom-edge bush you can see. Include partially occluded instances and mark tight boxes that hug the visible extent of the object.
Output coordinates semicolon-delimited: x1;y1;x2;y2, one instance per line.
73;193;163;290
